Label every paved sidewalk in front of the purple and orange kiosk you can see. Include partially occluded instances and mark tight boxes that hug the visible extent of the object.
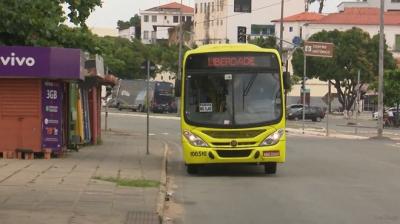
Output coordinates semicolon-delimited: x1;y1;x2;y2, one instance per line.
0;133;164;224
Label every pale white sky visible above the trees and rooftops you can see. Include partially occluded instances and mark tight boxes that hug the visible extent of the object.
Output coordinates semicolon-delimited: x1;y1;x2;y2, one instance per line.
86;0;342;28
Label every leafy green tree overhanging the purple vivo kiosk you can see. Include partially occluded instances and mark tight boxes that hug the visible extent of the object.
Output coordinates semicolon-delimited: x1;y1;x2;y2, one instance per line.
0;0;101;51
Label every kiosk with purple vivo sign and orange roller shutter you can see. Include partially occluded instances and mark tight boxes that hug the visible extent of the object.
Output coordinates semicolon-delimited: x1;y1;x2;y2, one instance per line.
0;47;85;157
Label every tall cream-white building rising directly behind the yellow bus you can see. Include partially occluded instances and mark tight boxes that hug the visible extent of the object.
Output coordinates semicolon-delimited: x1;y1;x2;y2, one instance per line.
194;0;305;45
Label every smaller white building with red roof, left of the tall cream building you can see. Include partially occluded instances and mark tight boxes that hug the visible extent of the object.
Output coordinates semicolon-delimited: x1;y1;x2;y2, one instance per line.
140;2;194;44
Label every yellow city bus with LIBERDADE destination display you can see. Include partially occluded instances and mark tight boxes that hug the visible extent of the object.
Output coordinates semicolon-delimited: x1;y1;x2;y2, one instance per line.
176;44;289;174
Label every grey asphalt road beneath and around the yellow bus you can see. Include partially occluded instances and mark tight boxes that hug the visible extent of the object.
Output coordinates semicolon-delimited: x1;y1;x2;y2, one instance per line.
104;114;400;224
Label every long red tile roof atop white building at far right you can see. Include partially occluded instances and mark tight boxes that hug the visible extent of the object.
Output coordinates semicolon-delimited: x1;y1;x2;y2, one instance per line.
310;7;400;25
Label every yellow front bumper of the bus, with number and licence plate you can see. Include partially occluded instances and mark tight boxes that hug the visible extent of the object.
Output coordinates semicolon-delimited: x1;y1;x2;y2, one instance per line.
183;141;286;164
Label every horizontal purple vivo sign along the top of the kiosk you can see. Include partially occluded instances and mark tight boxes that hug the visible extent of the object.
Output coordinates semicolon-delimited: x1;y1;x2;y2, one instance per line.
0;47;83;79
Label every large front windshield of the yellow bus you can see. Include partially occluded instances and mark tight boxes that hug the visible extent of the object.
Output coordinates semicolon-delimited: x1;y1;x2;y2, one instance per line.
185;71;282;127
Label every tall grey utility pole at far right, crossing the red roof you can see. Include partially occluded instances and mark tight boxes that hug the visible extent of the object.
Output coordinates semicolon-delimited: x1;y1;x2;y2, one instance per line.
378;0;385;138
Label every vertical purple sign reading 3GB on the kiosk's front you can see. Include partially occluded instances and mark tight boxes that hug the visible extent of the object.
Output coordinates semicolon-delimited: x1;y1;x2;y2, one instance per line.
42;81;63;151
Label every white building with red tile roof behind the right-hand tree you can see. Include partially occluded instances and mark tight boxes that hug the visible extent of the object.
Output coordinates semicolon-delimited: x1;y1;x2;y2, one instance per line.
273;3;400;110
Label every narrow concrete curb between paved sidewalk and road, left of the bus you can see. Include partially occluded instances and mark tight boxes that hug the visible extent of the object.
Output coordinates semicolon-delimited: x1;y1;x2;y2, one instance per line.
157;143;169;223
